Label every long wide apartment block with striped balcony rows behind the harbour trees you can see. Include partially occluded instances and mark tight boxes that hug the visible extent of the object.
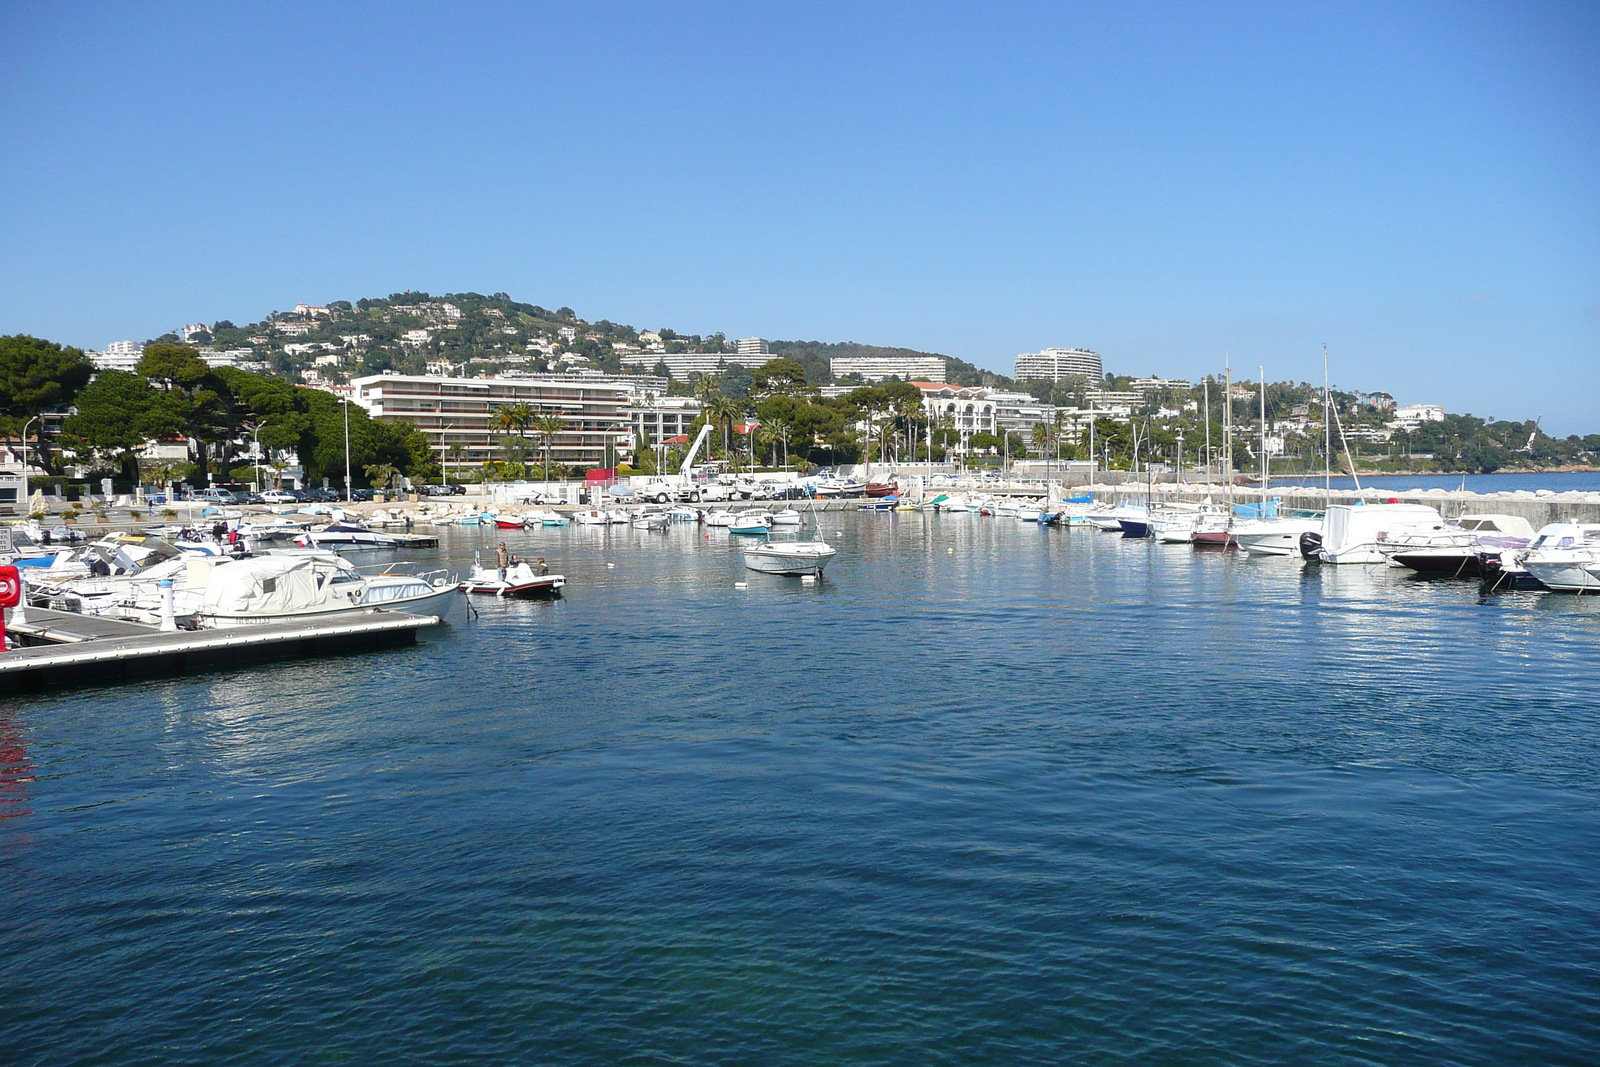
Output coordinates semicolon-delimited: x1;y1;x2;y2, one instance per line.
350;374;632;469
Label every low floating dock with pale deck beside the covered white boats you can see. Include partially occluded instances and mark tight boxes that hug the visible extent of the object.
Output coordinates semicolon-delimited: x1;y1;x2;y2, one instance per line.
0;608;438;693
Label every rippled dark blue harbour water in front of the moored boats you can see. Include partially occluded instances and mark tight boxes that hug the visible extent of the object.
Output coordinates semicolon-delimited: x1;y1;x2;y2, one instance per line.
0;515;1600;1067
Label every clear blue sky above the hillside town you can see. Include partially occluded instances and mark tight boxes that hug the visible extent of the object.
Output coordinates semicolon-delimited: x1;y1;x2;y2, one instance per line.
0;0;1600;434
